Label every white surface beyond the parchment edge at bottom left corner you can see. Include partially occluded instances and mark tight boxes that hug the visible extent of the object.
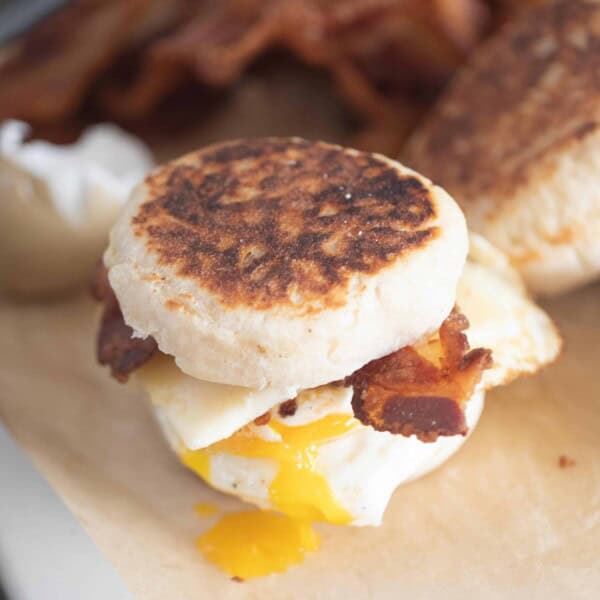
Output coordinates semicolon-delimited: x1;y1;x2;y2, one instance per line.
0;424;132;600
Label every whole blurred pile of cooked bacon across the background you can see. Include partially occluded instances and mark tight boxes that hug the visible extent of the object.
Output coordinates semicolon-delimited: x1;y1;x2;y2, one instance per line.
0;0;536;155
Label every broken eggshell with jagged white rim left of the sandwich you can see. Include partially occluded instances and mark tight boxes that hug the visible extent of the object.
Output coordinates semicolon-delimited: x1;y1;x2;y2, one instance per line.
0;121;152;295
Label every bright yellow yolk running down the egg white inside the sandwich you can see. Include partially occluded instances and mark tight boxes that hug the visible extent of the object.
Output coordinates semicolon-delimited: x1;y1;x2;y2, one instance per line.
181;414;356;525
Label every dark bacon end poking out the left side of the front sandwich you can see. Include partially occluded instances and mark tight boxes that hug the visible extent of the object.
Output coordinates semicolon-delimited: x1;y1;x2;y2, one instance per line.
91;266;158;383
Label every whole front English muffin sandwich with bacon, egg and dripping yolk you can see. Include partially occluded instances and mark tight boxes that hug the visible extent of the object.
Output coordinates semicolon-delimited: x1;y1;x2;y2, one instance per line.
95;138;560;577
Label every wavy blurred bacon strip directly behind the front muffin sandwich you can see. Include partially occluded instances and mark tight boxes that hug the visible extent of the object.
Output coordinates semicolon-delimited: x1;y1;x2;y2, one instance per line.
103;0;488;154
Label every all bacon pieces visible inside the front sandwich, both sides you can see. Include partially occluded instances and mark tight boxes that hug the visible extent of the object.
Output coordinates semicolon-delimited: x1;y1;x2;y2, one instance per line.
92;267;492;442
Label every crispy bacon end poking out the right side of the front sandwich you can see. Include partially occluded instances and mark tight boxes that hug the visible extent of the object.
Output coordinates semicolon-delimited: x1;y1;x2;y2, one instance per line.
346;310;492;442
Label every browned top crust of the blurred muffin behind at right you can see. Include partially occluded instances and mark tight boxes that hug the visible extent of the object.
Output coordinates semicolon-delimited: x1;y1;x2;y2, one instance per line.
403;0;600;209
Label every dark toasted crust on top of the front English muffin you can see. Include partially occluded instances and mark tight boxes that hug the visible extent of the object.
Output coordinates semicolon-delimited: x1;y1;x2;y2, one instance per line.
132;138;437;312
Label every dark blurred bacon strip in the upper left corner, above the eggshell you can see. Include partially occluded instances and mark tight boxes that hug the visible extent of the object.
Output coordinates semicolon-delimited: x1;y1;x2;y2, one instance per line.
0;0;183;124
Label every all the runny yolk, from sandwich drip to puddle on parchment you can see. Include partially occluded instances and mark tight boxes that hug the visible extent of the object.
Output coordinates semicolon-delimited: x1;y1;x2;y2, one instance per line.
181;414;357;579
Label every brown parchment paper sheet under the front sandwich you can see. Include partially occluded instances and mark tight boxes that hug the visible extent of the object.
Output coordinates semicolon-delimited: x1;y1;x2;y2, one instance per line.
0;278;600;600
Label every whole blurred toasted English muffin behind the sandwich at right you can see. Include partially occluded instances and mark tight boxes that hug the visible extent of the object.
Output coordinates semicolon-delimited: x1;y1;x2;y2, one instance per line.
402;0;600;294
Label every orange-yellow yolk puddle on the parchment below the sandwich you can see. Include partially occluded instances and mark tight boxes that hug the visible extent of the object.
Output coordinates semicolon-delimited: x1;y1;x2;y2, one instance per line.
197;511;319;579
